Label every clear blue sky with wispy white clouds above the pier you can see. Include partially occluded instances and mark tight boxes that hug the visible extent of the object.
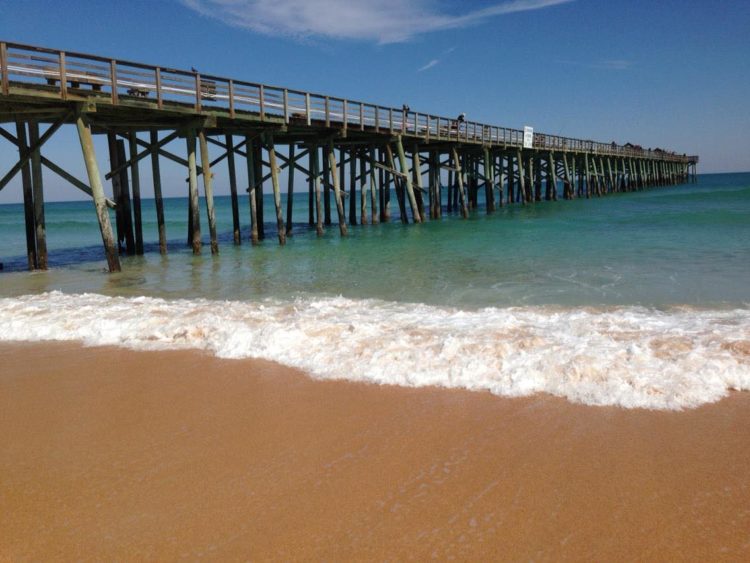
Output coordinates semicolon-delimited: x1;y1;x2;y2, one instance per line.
0;0;750;202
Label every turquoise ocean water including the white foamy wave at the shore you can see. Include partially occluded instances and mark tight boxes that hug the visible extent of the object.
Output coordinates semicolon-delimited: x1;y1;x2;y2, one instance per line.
0;174;750;408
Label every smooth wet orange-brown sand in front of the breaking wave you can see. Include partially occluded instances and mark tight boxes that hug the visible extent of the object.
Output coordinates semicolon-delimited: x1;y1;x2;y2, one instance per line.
0;344;750;561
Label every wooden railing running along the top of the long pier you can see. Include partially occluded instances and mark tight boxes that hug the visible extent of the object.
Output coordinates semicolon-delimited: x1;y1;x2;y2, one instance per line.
0;38;698;162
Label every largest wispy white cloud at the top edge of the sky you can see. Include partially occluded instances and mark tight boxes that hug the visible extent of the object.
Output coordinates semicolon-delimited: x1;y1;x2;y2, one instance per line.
181;0;573;43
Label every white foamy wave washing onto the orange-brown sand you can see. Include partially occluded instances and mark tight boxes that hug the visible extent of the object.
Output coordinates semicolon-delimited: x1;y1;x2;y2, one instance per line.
0;292;750;409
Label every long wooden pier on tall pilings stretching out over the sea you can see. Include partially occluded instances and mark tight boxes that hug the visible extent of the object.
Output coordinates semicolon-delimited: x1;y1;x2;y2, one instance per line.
0;42;698;271
